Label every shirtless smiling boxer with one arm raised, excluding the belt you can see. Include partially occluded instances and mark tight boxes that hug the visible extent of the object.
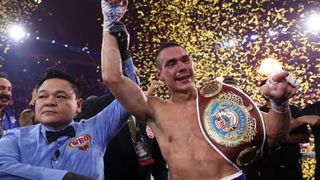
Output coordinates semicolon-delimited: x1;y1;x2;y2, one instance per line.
101;0;295;180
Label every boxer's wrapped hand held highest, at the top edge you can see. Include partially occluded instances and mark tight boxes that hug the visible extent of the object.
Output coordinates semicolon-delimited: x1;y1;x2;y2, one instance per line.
101;0;128;32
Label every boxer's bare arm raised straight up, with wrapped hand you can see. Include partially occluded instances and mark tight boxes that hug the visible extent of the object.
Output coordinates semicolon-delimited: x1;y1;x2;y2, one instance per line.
101;0;152;121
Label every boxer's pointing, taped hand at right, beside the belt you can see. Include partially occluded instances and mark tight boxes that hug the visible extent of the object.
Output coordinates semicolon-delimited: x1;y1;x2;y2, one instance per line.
261;71;297;112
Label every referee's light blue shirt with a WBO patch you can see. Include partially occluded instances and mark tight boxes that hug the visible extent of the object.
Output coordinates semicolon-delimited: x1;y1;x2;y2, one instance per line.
0;57;136;180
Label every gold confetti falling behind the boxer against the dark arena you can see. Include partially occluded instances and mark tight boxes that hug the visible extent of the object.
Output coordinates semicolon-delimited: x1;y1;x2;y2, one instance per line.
125;0;320;178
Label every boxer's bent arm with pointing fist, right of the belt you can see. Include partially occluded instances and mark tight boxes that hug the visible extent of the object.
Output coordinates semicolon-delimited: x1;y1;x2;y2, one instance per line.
261;72;297;146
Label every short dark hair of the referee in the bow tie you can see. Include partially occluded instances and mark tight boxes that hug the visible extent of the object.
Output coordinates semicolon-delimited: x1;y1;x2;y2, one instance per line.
36;68;81;98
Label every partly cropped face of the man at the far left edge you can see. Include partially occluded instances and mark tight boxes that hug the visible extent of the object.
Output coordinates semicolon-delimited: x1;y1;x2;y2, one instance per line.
0;78;12;107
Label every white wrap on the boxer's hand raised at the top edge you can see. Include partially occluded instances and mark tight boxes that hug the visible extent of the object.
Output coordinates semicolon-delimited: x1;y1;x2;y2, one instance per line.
101;0;127;32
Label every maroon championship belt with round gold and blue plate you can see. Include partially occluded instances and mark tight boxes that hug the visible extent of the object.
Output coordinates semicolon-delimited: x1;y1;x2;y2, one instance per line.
197;81;266;169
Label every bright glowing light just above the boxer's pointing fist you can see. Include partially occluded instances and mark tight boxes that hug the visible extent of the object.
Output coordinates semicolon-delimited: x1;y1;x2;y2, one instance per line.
258;58;282;76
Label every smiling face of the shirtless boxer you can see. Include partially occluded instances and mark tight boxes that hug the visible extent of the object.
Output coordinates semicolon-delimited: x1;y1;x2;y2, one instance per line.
156;46;195;92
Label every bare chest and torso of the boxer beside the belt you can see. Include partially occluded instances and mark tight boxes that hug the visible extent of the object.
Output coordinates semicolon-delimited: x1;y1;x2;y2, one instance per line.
151;102;239;179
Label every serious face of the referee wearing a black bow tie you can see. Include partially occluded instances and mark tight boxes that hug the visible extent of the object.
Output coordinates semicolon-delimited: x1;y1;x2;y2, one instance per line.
35;79;81;130
